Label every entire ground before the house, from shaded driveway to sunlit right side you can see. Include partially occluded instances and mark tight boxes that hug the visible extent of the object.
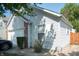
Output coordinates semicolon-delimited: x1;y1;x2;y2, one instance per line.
3;45;79;56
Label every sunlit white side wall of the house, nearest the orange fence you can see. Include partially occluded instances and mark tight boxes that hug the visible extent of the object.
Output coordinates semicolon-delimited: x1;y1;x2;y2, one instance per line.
58;20;72;49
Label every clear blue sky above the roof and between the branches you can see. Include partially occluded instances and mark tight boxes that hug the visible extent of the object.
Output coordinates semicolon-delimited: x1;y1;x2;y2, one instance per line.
5;3;65;16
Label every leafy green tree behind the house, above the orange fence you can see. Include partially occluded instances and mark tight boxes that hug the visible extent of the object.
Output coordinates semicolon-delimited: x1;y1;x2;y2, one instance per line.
61;3;79;32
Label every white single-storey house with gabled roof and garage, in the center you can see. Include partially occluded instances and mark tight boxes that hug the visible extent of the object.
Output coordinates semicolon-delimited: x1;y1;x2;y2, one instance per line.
4;7;73;50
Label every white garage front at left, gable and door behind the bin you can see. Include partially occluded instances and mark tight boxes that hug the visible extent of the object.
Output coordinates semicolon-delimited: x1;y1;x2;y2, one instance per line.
8;16;24;46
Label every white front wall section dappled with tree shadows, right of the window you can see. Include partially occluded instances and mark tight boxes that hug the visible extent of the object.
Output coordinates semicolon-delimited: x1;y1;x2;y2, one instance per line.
43;17;59;49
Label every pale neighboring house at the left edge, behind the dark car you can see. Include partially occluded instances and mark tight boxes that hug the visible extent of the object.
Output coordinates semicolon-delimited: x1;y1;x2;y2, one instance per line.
0;17;9;40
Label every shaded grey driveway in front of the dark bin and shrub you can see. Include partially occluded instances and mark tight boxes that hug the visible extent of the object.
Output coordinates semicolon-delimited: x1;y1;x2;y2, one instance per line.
1;48;47;56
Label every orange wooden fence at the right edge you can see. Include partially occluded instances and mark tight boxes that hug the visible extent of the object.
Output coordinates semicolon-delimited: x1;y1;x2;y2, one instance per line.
70;32;79;45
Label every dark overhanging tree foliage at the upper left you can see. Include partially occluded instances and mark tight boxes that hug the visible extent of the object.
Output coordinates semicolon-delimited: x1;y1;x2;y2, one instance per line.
0;3;37;20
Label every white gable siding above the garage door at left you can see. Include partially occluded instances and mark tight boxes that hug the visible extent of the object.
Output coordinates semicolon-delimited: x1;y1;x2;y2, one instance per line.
8;16;24;30
